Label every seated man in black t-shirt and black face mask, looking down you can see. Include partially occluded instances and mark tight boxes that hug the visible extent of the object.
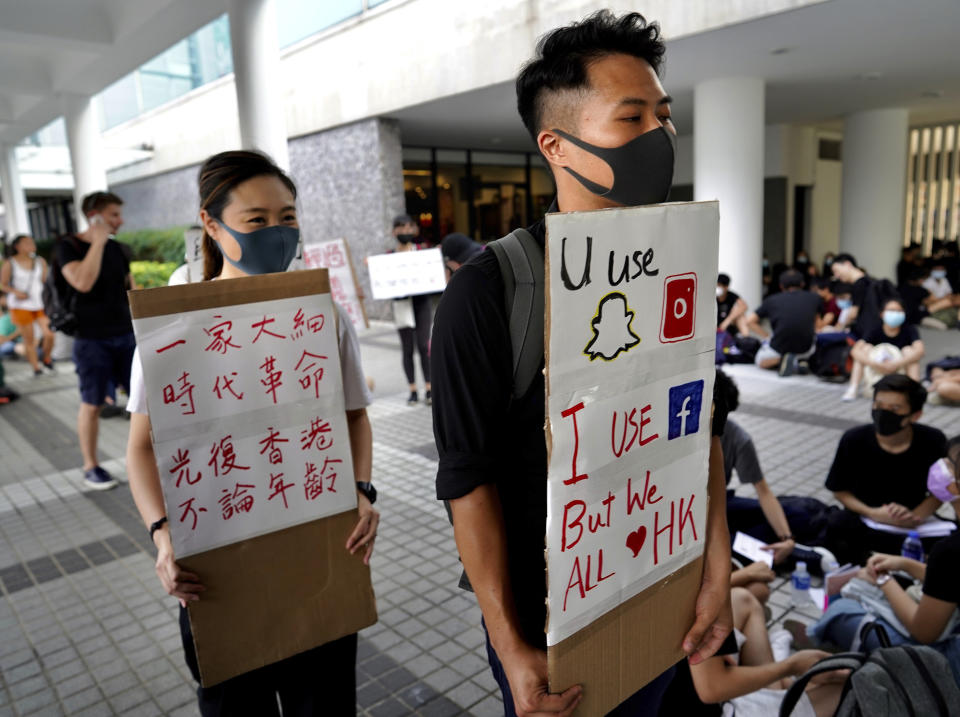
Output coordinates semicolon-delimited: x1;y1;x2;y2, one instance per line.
826;374;947;565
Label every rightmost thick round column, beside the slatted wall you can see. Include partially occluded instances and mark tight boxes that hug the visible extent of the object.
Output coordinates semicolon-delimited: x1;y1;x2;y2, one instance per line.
840;108;909;278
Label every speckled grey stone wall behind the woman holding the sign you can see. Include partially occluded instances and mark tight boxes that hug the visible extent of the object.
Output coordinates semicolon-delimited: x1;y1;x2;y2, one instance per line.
110;119;404;318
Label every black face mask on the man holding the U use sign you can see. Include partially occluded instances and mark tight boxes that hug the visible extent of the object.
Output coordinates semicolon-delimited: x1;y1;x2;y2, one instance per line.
553;127;676;207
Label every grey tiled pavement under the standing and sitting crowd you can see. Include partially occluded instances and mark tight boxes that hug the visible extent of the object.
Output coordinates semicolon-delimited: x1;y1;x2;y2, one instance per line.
0;324;960;717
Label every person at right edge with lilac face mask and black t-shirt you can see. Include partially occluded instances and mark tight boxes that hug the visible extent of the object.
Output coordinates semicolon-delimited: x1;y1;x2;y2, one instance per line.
809;436;960;683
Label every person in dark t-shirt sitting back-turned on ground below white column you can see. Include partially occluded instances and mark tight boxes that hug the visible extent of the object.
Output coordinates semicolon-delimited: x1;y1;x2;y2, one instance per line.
747;269;821;376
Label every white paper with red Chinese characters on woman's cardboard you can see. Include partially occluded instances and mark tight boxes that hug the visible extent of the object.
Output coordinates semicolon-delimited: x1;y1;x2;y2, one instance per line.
134;294;357;558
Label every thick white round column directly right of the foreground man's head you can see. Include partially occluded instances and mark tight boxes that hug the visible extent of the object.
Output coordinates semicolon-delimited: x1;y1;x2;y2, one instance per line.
693;77;765;308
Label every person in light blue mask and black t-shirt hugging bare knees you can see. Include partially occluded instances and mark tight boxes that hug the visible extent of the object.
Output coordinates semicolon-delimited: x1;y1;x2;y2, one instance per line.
842;299;924;401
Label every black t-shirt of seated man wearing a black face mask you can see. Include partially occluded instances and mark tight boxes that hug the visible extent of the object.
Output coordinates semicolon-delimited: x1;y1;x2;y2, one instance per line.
826;423;947;510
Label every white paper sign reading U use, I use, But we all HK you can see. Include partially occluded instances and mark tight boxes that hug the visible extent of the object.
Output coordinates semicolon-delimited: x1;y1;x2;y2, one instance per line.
547;202;719;645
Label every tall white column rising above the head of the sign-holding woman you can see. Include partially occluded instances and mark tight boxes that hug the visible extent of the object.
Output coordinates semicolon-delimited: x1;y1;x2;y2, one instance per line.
227;0;290;169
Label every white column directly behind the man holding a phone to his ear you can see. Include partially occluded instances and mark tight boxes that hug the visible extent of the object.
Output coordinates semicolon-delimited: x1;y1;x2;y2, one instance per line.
64;95;107;231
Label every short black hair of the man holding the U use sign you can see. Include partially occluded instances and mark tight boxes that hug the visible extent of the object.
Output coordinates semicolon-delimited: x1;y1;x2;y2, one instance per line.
517;10;665;141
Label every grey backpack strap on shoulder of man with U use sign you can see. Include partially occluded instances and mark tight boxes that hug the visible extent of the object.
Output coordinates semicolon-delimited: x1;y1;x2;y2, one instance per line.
489;229;545;398
